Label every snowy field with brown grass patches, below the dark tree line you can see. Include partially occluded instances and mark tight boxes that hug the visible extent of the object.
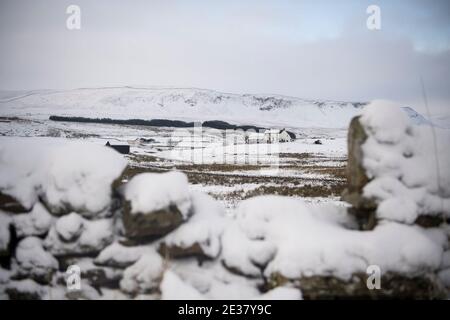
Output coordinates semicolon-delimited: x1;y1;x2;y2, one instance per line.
0;118;346;207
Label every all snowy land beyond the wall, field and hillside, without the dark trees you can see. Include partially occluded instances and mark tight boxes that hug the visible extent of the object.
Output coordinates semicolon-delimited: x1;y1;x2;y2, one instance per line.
0;87;358;208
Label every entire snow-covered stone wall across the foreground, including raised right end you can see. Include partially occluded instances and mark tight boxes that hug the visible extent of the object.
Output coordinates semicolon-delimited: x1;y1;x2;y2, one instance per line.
0;103;450;299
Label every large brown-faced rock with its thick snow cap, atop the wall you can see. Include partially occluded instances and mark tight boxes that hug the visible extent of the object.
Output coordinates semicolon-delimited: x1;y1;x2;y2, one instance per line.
123;172;192;241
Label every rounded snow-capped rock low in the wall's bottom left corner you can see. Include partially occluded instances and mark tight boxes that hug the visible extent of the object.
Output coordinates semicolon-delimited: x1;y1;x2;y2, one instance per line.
13;237;58;284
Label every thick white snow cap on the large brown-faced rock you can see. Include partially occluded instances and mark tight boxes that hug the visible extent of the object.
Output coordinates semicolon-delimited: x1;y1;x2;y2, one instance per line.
124;171;192;219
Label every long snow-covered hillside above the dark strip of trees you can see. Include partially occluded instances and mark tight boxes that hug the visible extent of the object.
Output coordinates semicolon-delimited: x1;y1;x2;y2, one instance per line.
0;87;365;128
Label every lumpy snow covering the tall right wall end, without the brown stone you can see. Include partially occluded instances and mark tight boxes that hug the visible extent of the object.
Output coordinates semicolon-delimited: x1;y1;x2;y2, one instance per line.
360;101;450;223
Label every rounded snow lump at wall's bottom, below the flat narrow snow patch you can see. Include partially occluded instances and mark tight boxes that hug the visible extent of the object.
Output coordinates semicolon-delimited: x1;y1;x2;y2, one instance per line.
120;251;164;294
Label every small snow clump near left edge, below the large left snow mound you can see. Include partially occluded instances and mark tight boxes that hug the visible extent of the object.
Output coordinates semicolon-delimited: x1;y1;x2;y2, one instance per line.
12;202;52;238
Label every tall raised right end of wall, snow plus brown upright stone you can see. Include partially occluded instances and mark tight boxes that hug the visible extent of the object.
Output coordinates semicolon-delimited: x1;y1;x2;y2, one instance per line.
344;101;450;229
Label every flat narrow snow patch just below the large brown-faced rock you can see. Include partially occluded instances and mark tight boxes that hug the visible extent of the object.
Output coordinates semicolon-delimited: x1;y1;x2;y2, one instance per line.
95;242;153;268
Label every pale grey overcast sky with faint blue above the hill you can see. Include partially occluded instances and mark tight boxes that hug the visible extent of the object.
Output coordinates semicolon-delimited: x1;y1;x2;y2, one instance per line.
0;0;450;112
